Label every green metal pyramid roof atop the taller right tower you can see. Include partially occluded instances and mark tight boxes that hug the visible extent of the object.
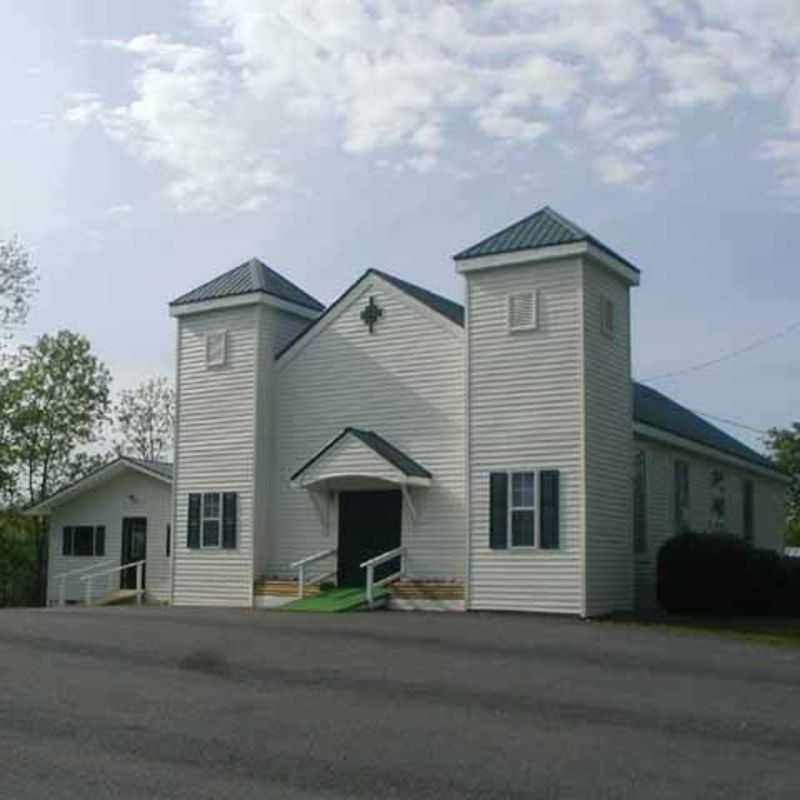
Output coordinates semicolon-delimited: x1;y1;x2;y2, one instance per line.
453;206;639;272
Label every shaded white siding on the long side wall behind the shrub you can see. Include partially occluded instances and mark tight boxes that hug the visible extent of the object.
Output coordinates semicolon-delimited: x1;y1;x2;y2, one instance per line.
634;436;785;609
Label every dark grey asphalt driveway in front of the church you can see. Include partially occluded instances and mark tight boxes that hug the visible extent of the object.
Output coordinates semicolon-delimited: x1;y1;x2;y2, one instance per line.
0;608;800;800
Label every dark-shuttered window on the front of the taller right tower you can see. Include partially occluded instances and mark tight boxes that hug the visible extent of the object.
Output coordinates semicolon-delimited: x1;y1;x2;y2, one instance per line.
489;470;560;550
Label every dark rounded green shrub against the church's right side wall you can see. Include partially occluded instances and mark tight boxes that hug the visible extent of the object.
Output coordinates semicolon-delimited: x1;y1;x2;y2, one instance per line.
658;533;800;616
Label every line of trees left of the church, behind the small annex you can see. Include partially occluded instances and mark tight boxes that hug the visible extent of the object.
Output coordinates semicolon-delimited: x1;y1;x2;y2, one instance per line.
0;238;175;606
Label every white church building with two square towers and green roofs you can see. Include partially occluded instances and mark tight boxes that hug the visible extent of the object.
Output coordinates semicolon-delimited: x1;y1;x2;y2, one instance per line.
34;208;786;616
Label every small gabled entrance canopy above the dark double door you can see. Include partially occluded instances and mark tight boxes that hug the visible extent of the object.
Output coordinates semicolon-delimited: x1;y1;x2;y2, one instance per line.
291;428;433;491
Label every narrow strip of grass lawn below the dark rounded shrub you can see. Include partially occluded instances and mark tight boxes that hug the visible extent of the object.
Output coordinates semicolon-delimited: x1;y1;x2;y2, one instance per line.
629;616;800;648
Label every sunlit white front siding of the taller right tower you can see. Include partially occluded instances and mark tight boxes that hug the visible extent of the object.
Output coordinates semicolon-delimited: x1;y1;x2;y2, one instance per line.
467;259;584;614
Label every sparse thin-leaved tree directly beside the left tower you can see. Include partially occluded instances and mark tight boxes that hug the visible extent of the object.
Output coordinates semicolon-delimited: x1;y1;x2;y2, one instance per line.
114;378;175;461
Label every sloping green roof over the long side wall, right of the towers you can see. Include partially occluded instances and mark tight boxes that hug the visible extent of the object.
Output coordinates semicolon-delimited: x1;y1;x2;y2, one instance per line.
633;383;780;472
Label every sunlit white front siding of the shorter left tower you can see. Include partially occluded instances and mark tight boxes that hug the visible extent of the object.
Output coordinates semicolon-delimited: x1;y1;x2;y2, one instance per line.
173;305;262;606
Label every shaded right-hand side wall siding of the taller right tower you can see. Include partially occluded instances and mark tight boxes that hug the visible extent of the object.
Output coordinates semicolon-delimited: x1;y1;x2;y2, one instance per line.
583;261;633;616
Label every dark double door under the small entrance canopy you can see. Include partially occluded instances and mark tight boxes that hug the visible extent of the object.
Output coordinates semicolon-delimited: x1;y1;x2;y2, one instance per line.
337;490;403;586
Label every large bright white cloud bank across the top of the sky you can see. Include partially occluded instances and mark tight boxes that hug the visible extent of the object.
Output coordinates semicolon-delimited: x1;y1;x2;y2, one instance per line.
64;0;800;212
